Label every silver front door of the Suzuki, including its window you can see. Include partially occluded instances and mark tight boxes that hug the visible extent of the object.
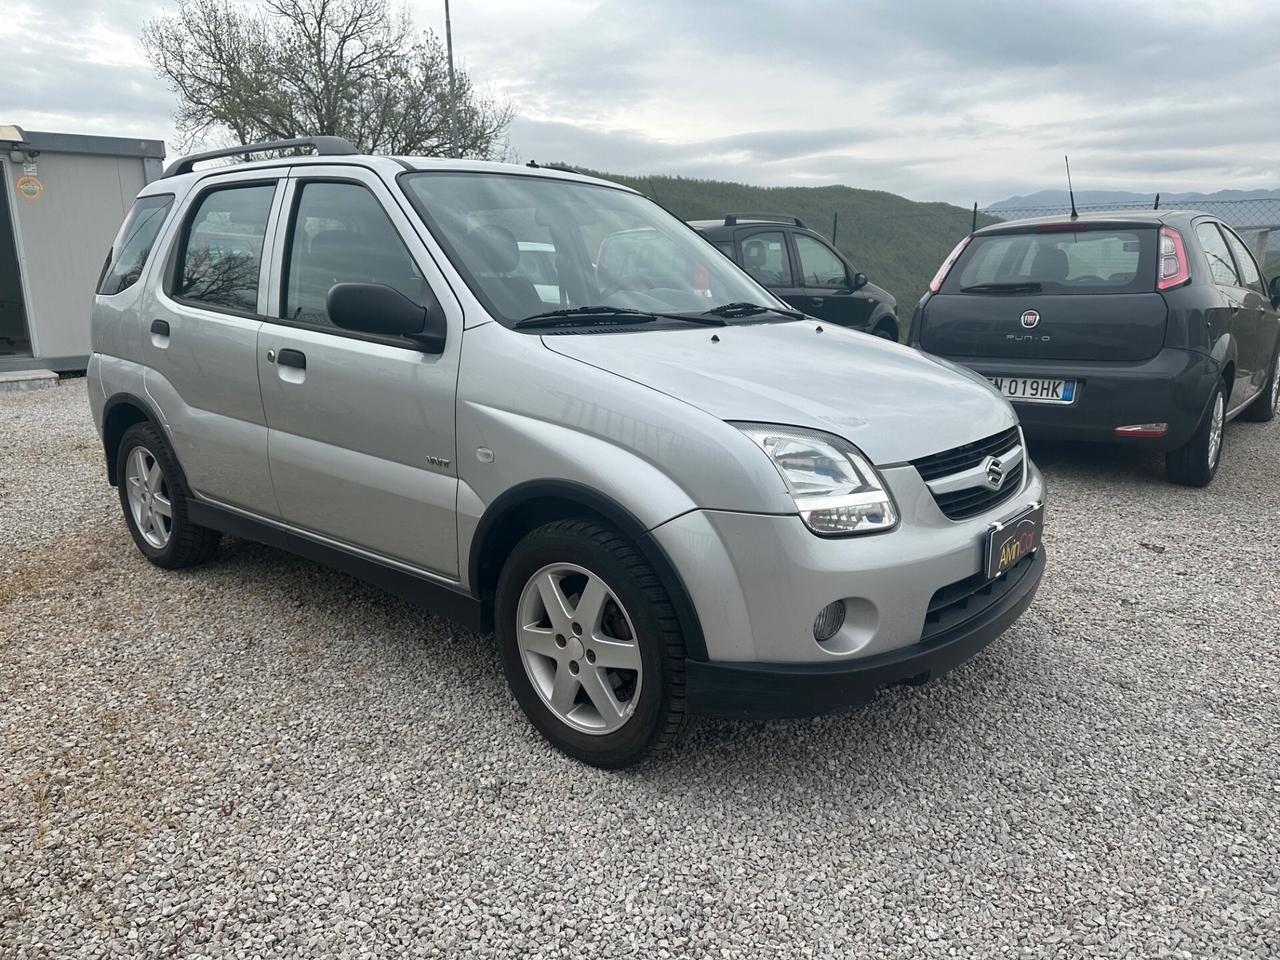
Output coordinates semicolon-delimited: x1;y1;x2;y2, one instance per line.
257;166;462;579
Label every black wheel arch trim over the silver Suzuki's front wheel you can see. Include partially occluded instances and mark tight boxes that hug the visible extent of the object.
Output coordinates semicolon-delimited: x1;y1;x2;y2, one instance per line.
467;480;708;660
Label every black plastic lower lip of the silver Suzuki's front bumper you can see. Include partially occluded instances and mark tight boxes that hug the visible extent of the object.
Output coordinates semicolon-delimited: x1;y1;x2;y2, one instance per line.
686;545;1046;718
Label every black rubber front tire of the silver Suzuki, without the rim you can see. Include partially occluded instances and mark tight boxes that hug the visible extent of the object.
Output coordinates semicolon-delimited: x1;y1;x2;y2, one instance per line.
494;520;685;769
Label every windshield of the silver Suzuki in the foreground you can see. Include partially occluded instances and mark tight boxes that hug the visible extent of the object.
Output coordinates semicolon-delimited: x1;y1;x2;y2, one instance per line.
402;173;787;326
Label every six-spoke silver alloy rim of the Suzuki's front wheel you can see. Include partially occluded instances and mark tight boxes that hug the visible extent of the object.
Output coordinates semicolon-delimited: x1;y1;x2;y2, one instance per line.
516;563;644;735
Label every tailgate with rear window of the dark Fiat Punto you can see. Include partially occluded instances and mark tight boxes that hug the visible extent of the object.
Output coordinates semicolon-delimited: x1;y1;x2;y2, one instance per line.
920;221;1169;361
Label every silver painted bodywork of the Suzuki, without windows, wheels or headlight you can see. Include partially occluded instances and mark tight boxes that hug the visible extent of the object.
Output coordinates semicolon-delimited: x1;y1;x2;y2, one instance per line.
88;157;1043;663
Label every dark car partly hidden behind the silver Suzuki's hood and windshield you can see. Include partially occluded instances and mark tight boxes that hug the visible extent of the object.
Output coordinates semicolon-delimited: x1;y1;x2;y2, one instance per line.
689;214;899;340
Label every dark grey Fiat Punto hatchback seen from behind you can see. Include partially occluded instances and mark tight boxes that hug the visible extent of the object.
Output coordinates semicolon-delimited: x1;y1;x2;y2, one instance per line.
910;211;1280;486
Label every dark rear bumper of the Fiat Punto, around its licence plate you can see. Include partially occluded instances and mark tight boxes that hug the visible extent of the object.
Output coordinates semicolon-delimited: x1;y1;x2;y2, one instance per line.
954;348;1219;451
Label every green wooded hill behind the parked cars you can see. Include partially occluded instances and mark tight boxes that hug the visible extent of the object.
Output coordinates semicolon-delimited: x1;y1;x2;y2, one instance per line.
579;169;993;317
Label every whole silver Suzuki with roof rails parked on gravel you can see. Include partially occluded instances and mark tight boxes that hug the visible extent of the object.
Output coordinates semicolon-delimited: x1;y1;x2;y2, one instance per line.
88;137;1044;767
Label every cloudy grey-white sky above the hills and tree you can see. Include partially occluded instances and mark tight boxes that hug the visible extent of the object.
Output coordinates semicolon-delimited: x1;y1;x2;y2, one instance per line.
0;0;1280;204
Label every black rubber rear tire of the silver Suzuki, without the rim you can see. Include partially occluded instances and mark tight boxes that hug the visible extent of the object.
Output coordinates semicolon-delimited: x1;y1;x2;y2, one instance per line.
115;422;221;570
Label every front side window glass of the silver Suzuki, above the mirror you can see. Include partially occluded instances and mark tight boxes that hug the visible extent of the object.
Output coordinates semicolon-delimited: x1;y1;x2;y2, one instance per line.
282;182;428;325
